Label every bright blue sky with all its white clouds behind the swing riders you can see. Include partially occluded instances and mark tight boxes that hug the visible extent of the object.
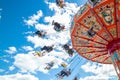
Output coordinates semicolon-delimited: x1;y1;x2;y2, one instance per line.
0;0;117;80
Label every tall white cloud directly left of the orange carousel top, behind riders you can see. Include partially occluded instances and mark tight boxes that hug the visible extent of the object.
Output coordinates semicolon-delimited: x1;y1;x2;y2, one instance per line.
26;2;78;47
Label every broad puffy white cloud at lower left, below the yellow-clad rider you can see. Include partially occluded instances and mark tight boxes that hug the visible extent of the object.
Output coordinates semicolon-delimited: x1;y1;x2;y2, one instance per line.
14;52;68;73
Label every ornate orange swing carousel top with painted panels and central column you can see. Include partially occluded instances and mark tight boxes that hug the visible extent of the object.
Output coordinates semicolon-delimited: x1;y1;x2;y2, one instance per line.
71;0;120;79
